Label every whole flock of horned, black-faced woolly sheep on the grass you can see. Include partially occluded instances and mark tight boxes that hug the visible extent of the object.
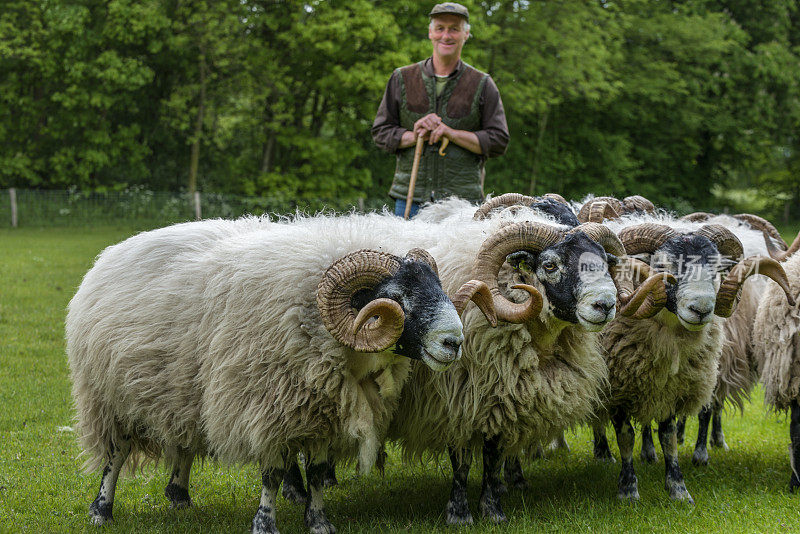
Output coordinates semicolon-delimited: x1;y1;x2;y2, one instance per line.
66;194;800;533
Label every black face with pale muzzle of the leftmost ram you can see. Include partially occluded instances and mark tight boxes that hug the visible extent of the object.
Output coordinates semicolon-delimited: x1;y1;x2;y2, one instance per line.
354;260;464;371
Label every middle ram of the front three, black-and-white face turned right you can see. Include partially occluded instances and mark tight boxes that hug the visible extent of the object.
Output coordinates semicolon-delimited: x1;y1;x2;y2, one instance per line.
389;203;636;524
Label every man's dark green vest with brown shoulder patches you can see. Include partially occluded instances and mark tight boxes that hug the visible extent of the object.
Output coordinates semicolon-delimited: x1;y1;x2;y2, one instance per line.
389;61;488;202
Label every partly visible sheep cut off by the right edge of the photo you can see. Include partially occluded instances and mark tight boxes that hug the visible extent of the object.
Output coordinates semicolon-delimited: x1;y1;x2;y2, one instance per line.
753;245;800;492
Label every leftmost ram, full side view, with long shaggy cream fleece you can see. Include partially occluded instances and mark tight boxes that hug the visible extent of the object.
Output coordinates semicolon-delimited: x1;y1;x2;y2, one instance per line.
66;216;494;533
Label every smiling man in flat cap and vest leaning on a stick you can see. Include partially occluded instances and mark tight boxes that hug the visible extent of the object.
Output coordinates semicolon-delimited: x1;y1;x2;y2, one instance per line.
372;2;509;217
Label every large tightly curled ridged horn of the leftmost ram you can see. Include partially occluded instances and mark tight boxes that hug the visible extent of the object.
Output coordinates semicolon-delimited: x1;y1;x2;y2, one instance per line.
317;250;405;352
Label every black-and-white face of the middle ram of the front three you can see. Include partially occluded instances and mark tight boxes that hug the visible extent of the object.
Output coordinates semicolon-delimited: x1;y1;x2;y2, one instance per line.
509;232;617;332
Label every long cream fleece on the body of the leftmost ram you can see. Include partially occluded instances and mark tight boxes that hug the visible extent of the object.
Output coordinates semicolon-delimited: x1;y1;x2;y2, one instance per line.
66;215;462;476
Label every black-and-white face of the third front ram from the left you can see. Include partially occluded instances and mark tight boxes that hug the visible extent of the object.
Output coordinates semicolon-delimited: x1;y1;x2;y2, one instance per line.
650;234;724;331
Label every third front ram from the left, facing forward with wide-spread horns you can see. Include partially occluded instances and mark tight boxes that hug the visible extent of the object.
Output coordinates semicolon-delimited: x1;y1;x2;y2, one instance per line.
595;221;791;502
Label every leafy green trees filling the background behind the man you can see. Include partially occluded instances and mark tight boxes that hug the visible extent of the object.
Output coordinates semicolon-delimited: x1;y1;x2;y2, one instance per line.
0;0;800;219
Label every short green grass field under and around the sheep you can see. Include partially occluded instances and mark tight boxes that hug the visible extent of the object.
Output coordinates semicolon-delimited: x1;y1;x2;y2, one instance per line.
0;228;800;533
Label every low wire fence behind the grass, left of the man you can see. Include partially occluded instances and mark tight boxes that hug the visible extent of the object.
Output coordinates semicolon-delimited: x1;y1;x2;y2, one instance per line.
0;188;389;228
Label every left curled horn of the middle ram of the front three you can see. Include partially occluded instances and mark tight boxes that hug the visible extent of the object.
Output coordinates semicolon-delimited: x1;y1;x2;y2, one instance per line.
473;221;563;323
